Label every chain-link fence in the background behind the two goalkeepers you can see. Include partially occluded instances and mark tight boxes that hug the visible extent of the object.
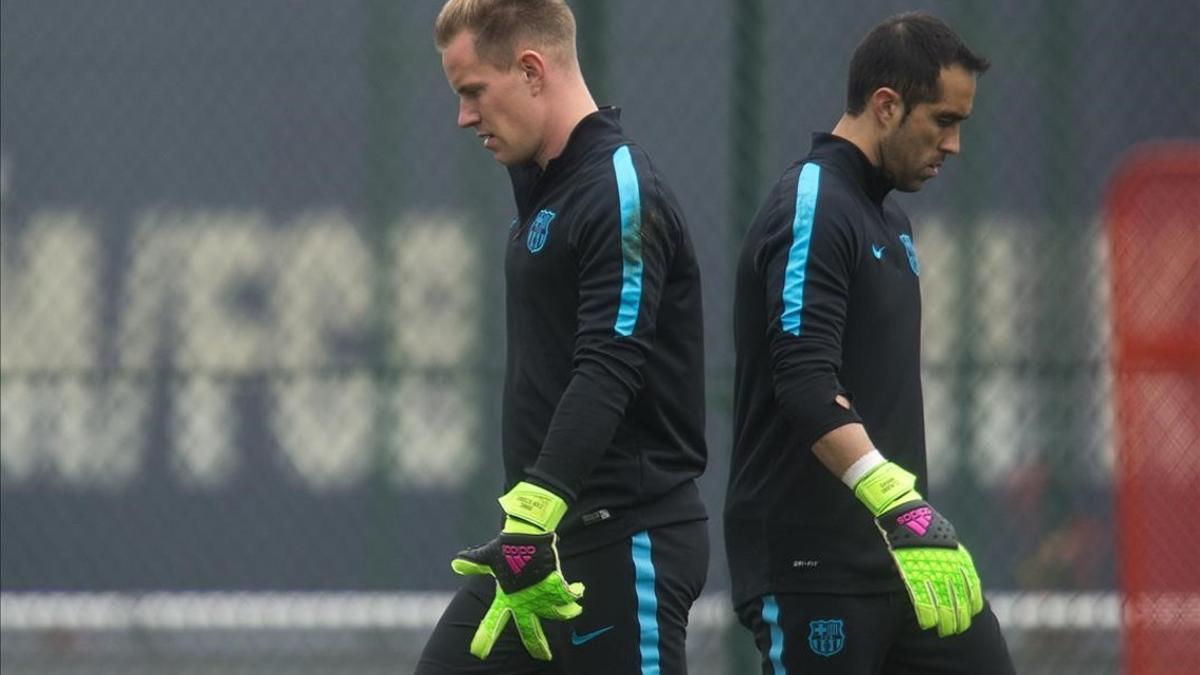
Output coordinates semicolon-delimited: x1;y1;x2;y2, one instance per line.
0;0;1200;675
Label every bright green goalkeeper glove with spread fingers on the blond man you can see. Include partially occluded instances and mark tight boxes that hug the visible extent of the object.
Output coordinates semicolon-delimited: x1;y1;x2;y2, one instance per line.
450;483;583;661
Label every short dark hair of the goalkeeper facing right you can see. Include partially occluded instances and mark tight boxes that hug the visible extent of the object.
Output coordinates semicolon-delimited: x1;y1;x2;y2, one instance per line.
846;12;991;115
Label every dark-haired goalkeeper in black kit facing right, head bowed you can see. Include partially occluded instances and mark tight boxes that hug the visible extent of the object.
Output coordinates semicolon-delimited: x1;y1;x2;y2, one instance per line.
725;14;1013;675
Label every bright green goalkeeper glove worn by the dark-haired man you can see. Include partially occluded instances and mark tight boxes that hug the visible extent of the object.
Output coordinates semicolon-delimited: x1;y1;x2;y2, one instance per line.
854;461;983;638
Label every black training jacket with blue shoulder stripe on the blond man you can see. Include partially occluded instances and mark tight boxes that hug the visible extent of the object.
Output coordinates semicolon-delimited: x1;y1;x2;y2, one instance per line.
503;108;707;555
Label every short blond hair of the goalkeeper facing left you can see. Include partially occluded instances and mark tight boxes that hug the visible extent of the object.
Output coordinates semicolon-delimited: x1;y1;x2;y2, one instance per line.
433;0;576;68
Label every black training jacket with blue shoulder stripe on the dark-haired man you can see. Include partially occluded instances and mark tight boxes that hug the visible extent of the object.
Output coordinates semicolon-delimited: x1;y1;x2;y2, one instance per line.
725;133;925;603
